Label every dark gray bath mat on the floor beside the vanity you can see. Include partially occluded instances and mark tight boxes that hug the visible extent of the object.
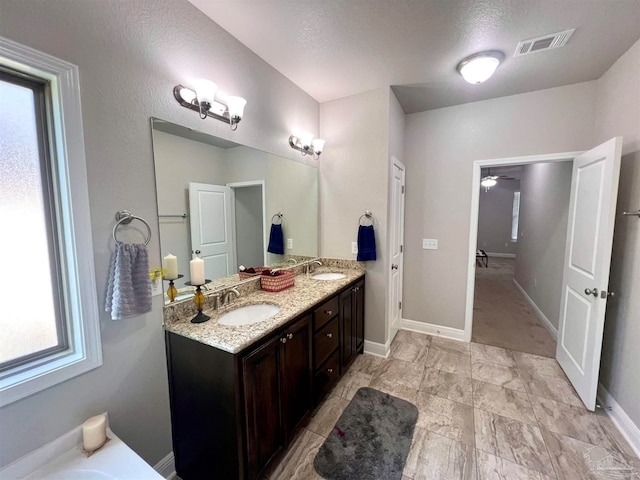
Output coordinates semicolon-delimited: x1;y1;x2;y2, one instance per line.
313;387;418;480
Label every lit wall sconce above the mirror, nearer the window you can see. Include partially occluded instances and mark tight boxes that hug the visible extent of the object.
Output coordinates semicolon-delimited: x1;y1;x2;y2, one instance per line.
173;80;247;131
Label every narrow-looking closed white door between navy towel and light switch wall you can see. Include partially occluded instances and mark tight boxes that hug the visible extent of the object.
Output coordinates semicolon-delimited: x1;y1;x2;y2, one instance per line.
389;157;405;340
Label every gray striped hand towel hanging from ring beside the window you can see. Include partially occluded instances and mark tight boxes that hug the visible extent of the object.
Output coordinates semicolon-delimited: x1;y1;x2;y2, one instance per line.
105;242;151;320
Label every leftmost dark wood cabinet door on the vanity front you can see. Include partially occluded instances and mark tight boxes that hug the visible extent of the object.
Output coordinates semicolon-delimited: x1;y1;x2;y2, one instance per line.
242;336;285;478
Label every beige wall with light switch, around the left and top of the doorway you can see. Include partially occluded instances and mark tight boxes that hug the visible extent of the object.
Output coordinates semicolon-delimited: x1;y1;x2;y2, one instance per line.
404;82;596;329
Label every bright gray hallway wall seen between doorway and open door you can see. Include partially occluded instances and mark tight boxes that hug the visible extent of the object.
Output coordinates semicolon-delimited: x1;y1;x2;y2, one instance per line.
515;162;573;330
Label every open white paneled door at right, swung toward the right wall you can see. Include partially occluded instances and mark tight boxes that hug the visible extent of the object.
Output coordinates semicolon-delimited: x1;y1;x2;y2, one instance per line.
556;137;622;410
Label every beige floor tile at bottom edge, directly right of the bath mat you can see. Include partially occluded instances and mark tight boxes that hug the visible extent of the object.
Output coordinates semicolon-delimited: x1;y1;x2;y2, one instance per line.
404;428;475;480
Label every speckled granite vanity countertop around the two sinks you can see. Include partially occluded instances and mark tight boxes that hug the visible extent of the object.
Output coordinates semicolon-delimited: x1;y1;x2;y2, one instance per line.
164;262;365;353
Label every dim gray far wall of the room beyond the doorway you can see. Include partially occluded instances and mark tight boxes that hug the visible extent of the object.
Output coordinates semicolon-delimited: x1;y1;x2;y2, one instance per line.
478;180;520;255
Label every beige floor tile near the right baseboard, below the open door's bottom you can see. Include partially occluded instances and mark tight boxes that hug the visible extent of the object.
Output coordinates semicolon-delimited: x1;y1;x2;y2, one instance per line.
531;395;636;453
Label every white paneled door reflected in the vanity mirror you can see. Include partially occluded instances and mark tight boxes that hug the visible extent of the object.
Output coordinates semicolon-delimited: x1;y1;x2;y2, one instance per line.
189;183;236;279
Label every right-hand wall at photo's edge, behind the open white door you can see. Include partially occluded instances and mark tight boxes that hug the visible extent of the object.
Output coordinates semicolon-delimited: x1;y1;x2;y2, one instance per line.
594;41;640;430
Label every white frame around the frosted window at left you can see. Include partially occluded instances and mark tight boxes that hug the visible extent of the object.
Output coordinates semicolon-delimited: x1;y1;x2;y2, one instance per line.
0;37;102;407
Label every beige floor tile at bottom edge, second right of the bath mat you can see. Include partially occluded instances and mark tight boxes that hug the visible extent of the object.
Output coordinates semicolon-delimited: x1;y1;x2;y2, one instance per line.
474;409;555;477
